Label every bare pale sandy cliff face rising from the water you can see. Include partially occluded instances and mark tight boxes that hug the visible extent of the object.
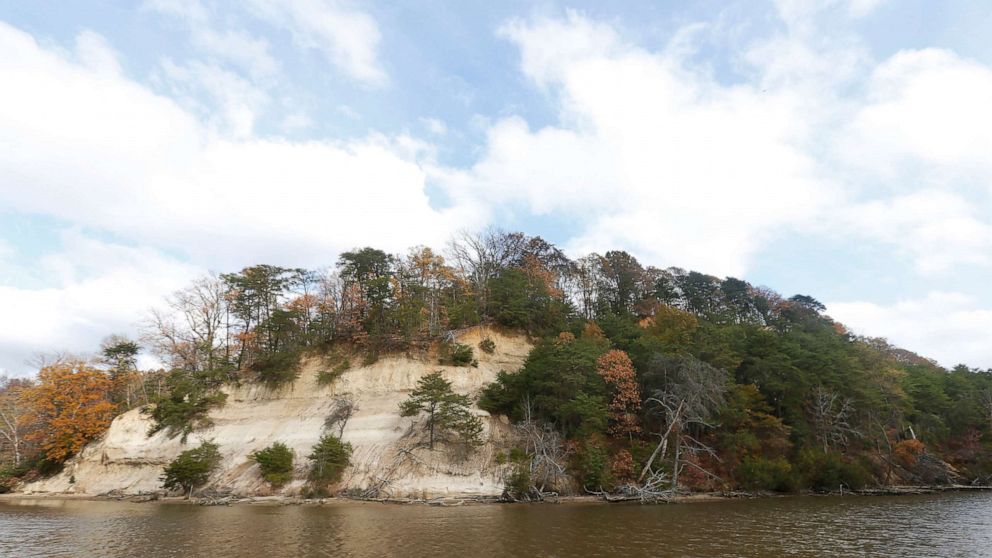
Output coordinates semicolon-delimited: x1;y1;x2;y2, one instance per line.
23;328;531;497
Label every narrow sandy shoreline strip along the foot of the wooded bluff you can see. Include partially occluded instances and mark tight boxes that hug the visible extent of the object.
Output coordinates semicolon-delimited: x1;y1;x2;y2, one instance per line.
0;485;992;507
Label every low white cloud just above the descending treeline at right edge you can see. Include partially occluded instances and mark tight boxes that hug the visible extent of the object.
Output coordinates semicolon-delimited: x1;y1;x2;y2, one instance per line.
827;291;992;366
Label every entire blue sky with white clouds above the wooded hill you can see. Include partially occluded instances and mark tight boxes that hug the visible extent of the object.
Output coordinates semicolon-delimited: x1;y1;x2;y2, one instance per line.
0;0;992;375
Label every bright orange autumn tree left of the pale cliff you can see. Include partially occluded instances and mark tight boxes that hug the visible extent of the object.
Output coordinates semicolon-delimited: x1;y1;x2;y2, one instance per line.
23;361;114;463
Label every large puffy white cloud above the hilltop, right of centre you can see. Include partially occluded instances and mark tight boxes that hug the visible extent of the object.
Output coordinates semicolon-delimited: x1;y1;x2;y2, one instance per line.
442;13;833;274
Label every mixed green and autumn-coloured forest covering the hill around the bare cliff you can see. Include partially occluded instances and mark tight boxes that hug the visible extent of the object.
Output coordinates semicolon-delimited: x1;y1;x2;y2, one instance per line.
0;230;992;500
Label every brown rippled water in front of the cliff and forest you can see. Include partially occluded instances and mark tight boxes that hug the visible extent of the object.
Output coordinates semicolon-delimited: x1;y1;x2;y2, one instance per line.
0;493;992;558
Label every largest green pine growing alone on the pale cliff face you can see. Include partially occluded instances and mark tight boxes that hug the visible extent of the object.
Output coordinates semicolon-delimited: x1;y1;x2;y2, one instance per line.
400;370;482;449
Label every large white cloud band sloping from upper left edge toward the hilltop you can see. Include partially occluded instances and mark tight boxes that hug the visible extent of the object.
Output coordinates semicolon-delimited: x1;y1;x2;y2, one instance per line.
0;25;474;269
